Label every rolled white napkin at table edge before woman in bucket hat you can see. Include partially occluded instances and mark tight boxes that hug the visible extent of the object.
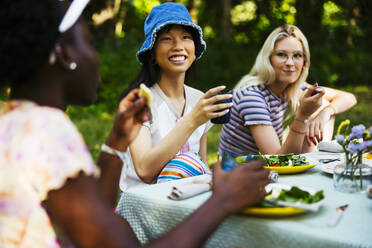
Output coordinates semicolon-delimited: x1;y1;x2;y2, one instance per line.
168;177;212;200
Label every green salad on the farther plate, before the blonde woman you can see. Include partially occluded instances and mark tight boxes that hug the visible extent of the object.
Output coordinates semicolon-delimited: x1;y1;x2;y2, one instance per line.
260;153;309;167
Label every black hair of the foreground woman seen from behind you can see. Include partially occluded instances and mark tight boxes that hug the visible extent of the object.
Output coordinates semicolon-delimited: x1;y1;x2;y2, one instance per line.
0;0;63;87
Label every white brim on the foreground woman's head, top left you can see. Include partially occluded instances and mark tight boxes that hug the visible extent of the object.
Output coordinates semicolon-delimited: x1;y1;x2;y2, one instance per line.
58;0;90;33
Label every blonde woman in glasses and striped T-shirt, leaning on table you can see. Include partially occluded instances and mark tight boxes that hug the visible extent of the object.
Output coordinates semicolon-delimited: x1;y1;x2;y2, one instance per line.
219;25;356;154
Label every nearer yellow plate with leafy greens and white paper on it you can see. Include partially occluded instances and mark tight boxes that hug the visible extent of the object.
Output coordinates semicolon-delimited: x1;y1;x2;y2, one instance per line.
242;183;324;217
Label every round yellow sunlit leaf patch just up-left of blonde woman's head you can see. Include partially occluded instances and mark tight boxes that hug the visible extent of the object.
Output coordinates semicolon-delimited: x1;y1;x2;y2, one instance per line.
231;1;257;26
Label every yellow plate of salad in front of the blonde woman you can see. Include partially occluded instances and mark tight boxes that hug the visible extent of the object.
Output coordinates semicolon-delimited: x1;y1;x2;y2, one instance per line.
260;153;315;174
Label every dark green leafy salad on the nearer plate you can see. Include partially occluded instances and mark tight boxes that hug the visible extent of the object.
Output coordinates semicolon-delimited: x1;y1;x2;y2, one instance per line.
256;186;324;208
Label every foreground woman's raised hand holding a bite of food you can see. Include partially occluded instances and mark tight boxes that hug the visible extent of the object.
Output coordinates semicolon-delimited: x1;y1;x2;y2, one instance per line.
106;89;151;150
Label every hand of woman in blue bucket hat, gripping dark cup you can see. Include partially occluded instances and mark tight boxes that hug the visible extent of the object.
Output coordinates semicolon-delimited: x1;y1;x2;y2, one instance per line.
188;86;232;127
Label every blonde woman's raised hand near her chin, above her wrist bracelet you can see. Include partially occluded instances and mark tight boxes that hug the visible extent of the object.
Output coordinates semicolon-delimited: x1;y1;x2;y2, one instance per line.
297;83;325;119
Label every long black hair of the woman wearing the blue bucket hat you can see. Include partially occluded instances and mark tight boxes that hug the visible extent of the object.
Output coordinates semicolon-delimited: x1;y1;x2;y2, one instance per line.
121;24;197;99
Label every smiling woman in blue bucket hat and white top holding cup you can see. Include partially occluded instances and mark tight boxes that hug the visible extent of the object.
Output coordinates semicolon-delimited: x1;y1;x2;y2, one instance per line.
120;3;231;191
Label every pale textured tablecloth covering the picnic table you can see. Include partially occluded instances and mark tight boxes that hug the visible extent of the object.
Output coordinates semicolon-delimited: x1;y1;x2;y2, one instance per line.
117;153;372;248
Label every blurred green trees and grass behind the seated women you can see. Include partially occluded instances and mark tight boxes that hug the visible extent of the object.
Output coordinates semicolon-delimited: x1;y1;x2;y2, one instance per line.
68;0;372;161
